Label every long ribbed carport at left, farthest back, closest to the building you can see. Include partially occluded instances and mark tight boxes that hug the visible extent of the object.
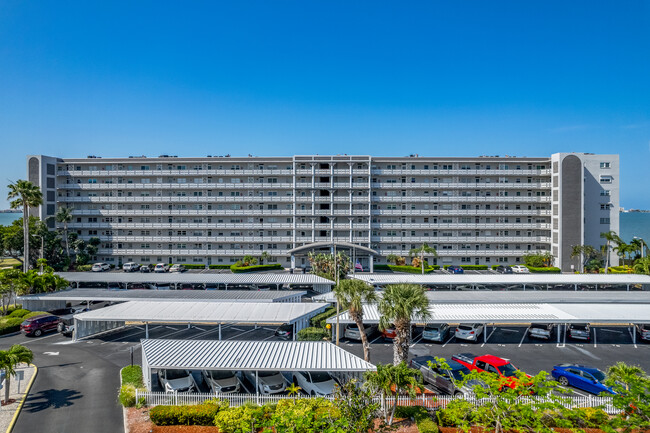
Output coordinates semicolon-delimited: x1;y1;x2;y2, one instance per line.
57;272;334;293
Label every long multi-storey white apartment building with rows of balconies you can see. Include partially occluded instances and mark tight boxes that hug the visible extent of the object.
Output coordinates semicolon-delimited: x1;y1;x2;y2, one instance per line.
27;153;619;270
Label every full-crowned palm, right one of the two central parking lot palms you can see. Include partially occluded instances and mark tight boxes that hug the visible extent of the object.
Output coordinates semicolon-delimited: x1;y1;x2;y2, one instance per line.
377;284;431;365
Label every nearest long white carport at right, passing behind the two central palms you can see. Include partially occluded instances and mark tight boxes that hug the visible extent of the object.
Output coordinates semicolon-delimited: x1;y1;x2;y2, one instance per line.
327;303;650;344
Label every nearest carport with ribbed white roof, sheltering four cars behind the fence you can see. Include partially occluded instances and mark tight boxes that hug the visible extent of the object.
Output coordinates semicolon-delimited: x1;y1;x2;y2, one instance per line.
141;339;376;392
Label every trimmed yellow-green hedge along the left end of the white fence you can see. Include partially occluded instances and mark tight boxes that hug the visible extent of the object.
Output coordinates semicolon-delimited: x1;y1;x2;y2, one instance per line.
149;400;228;426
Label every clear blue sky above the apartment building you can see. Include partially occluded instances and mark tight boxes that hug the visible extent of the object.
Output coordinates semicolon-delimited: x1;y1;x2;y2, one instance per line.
0;0;650;209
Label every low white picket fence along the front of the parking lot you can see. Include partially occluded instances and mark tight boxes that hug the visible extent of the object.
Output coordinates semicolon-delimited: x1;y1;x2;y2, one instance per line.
135;390;618;414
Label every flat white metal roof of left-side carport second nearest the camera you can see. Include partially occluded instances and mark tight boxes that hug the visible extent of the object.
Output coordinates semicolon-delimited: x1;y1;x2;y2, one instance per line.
74;301;327;325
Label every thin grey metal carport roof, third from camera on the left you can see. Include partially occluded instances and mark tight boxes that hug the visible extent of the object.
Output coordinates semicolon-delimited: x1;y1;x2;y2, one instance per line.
18;289;307;302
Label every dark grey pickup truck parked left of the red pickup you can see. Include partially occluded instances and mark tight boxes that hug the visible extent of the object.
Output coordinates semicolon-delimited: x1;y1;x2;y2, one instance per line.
410;356;480;395
